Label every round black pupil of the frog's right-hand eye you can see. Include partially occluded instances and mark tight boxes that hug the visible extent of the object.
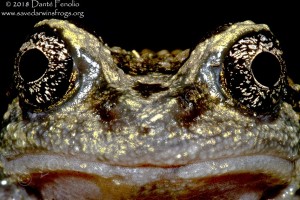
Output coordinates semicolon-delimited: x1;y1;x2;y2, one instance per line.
251;52;281;87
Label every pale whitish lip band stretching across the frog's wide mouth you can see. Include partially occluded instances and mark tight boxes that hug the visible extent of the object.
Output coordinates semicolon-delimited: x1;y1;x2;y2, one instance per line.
2;154;295;185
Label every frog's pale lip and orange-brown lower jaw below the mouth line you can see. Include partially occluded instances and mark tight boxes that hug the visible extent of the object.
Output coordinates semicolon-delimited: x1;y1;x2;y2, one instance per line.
3;155;295;199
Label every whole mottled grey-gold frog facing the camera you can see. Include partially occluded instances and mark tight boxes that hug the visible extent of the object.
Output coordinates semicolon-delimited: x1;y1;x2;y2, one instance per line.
0;19;300;200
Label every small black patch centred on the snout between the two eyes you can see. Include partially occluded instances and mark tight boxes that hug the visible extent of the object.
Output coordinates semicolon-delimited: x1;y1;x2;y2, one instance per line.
132;82;169;98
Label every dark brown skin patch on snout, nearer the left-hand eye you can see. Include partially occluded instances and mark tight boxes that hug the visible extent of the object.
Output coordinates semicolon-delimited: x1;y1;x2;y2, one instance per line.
93;88;120;122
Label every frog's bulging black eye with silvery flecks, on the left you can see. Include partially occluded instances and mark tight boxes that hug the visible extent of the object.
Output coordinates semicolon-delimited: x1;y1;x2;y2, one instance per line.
13;31;73;109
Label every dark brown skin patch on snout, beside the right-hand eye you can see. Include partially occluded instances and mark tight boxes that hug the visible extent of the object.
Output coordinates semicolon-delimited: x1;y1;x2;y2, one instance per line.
176;84;212;126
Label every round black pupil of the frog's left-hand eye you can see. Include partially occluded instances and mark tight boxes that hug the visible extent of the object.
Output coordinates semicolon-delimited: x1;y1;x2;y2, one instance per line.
19;49;48;82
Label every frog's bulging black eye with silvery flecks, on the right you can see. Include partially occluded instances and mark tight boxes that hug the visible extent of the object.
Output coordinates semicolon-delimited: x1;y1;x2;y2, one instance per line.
221;32;286;114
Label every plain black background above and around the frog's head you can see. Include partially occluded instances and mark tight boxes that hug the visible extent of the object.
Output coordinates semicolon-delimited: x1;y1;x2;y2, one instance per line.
0;0;300;117
